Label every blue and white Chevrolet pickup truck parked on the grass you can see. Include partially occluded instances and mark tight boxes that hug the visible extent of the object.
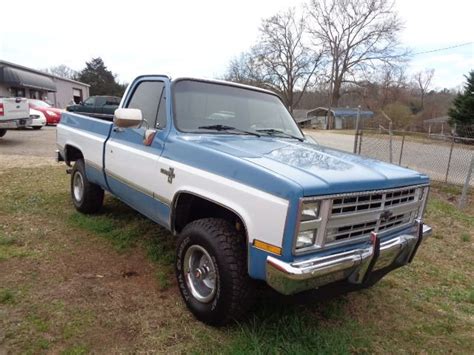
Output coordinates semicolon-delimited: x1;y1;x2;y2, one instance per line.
57;75;431;325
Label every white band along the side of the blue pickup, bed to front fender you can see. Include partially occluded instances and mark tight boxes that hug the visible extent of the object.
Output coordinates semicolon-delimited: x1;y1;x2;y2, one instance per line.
58;126;289;247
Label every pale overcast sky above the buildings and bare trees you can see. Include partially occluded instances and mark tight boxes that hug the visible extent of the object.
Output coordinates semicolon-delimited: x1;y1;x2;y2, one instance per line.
0;0;474;88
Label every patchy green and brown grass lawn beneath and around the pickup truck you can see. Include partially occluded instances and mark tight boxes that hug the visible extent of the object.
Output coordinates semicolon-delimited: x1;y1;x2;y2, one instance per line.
0;167;474;354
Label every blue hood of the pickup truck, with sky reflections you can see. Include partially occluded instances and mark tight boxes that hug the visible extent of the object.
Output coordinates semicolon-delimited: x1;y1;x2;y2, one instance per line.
163;133;429;198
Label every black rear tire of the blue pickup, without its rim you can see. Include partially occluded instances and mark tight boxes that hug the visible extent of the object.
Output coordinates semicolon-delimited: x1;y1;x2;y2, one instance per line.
71;159;104;214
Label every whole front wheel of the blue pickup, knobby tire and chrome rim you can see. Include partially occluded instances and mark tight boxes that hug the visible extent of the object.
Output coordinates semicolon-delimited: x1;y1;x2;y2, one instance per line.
176;218;253;326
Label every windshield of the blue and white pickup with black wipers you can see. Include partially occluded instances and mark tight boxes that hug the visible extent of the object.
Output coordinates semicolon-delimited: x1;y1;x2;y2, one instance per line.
174;80;303;139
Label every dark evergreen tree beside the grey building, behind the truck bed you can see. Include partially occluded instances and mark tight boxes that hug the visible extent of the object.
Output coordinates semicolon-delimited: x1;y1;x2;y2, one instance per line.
77;57;125;96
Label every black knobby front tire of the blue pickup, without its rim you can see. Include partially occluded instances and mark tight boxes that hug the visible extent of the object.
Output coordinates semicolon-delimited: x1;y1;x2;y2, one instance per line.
175;218;254;326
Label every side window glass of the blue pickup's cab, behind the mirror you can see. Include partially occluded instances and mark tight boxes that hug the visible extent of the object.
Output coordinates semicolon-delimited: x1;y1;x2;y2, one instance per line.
127;81;165;128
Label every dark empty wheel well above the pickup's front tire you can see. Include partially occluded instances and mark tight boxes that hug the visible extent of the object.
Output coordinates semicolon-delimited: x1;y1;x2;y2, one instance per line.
171;193;247;236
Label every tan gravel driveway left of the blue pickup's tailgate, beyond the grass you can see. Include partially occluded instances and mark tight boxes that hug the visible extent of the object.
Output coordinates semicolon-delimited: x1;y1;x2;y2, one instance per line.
0;126;57;170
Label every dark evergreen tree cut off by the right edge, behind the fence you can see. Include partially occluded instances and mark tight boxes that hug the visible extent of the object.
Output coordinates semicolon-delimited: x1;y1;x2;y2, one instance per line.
448;70;474;127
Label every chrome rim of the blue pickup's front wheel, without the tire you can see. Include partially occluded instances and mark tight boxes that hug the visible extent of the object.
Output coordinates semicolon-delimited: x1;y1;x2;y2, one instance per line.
183;245;217;303
